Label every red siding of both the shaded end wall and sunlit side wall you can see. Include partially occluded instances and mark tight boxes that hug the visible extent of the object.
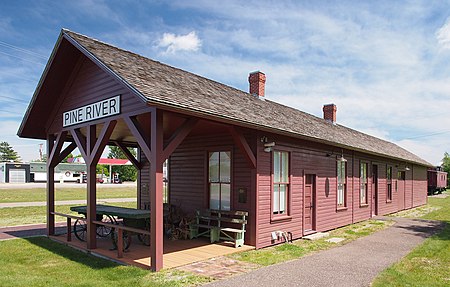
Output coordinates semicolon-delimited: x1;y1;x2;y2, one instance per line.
136;120;427;251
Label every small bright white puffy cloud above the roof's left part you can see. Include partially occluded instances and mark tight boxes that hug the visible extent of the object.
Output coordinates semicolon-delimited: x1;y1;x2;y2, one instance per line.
158;31;202;53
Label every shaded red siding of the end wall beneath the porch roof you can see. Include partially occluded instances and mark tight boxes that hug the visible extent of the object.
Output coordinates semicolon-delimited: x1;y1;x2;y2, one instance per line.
141;129;255;245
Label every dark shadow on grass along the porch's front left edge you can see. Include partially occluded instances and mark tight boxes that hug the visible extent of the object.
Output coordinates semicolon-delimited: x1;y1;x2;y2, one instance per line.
24;236;119;269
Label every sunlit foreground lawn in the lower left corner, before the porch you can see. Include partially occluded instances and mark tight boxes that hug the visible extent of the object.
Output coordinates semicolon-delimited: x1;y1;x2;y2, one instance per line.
0;237;211;287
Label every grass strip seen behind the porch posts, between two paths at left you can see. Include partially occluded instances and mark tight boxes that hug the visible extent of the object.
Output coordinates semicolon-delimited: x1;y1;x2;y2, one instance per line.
0;202;136;227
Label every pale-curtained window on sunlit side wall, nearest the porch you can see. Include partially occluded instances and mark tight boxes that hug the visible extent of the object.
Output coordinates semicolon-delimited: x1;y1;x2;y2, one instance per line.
272;151;289;214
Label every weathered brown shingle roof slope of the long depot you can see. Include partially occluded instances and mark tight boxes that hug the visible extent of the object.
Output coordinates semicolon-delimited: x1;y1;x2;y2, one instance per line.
63;30;431;166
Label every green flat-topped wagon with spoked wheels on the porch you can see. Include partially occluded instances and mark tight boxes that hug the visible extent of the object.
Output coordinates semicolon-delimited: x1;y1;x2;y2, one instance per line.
70;204;150;250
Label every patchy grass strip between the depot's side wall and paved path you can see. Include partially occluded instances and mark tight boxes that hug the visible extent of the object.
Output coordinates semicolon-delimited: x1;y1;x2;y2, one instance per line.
229;220;393;266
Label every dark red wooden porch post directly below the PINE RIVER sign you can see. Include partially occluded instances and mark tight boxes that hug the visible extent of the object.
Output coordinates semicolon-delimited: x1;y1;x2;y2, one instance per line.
85;125;97;249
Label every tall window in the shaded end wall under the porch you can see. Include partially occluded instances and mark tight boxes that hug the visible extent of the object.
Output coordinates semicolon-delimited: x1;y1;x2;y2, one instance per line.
208;151;231;210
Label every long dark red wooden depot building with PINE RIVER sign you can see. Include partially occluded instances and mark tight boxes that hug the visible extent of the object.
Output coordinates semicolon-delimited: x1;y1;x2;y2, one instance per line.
18;30;431;270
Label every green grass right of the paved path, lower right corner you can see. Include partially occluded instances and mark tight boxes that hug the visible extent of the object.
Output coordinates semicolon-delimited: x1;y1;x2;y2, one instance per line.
373;192;450;286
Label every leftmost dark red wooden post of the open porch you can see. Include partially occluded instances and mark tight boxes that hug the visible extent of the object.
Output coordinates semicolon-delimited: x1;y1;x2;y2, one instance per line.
47;135;55;236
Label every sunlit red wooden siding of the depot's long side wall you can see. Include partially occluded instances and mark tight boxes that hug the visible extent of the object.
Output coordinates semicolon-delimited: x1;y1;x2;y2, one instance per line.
256;139;427;248
